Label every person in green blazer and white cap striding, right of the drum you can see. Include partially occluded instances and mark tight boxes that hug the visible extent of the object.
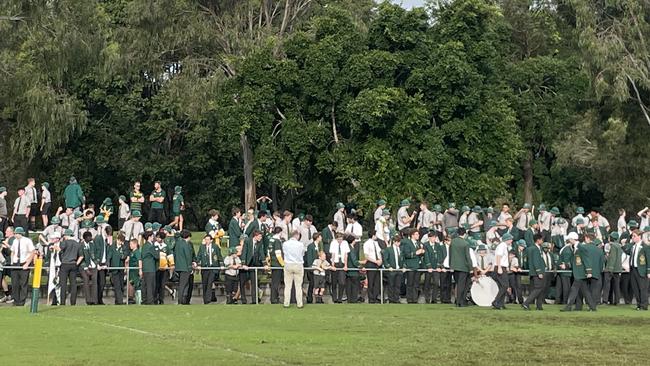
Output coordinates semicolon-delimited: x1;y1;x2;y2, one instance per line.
561;232;596;311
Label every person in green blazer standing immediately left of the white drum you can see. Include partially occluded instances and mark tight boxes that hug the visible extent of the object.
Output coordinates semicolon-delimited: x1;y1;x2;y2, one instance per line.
448;228;473;307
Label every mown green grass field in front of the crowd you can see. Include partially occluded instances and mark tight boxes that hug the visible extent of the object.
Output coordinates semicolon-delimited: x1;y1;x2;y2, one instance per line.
0;304;650;365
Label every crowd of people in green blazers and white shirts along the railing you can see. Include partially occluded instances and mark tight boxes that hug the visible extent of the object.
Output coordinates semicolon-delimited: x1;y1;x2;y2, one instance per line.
0;178;650;311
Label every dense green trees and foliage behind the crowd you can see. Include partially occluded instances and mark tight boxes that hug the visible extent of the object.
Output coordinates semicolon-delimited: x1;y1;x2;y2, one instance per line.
0;0;650;224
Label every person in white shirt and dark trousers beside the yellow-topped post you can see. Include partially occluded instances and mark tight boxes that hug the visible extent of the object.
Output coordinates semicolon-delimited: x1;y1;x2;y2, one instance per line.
11;227;36;306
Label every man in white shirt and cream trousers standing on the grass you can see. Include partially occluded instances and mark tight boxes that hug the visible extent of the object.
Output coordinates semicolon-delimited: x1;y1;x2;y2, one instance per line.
282;230;305;309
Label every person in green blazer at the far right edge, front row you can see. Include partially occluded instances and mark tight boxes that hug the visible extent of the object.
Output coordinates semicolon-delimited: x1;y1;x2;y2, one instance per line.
623;229;650;310
